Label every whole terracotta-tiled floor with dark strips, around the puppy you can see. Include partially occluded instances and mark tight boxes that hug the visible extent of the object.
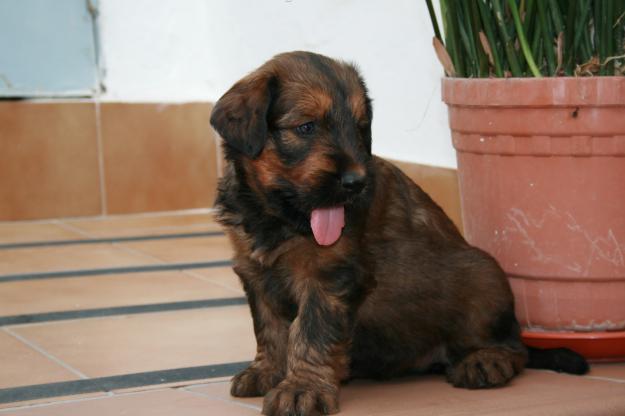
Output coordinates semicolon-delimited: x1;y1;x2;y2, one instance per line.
0;211;625;416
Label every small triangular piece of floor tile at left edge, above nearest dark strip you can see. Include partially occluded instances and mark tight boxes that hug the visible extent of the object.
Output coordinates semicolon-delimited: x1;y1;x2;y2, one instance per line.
0;330;78;389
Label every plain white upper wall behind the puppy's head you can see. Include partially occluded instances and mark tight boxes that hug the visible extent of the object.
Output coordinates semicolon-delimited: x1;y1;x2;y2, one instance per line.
100;0;456;167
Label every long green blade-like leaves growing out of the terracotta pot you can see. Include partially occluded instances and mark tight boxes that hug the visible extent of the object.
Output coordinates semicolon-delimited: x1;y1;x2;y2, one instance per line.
426;0;625;78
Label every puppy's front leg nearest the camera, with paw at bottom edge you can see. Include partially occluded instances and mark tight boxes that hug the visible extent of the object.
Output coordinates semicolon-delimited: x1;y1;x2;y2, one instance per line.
263;283;353;416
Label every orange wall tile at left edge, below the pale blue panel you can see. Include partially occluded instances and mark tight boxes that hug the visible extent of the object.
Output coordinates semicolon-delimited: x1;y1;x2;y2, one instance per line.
0;101;100;220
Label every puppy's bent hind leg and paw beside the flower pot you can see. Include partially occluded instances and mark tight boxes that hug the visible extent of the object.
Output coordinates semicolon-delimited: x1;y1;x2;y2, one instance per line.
447;248;528;389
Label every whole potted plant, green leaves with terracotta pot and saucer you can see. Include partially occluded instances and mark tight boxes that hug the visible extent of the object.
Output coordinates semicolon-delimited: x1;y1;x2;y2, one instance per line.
427;0;625;360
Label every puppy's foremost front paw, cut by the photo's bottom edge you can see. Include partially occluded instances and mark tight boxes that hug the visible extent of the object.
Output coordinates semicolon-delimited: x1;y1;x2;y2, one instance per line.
263;379;339;416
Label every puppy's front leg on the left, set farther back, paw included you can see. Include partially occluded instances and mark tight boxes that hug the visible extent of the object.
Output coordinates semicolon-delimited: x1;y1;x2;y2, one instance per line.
230;270;289;397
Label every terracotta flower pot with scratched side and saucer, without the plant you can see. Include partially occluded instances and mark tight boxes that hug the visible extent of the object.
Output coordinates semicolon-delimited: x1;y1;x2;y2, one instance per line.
442;77;625;359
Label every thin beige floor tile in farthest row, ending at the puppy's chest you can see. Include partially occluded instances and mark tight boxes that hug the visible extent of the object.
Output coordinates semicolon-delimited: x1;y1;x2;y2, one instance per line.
62;212;221;237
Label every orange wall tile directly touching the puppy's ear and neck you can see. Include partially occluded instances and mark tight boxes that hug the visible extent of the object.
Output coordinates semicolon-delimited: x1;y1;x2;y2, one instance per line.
101;103;217;214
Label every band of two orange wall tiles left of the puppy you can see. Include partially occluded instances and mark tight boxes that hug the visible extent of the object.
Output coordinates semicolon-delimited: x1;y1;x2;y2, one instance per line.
0;101;217;221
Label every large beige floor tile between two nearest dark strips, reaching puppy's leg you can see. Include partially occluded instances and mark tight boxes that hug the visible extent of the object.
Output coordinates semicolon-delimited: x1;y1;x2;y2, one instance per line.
12;305;256;377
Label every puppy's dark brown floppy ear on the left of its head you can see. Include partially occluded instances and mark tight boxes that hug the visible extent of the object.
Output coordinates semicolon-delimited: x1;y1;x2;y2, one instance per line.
211;72;276;158
